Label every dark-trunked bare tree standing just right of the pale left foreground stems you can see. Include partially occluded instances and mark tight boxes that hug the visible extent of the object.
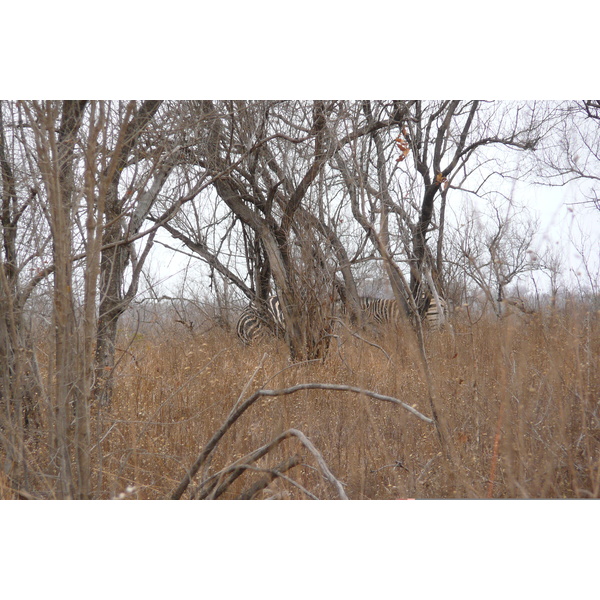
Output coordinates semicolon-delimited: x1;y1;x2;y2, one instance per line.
48;100;214;405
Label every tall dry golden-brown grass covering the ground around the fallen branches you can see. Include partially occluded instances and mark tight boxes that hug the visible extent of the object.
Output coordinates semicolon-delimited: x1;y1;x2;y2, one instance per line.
0;311;600;499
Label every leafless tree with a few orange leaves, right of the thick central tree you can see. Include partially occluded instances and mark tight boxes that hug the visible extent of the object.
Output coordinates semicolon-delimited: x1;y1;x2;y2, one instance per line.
328;101;551;324
